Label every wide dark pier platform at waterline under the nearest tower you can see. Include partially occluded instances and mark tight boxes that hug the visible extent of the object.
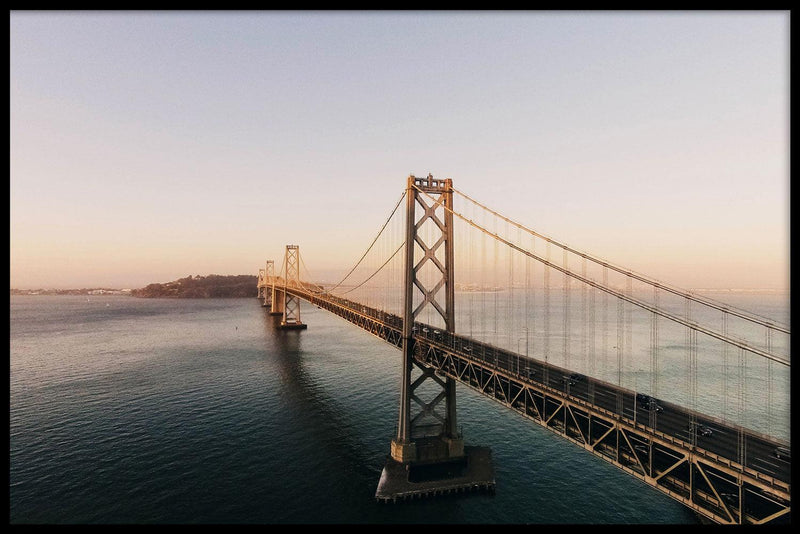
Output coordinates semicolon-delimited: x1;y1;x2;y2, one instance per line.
375;446;495;503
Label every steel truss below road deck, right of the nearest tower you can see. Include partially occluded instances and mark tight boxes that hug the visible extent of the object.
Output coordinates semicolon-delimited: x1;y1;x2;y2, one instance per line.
418;344;790;524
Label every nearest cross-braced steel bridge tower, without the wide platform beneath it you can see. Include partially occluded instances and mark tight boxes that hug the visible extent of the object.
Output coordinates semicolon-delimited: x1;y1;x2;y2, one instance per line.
391;174;464;464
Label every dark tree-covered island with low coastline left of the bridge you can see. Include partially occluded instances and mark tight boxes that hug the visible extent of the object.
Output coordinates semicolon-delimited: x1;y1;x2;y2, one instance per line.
11;274;258;298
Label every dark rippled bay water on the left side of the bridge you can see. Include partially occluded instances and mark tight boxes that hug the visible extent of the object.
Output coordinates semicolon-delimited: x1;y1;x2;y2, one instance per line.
10;296;784;524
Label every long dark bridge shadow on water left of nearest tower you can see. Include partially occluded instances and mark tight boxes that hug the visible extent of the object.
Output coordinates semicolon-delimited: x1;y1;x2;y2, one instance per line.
264;311;478;523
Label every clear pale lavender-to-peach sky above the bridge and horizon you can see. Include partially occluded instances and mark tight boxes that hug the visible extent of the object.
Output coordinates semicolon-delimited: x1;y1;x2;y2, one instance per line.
10;11;790;289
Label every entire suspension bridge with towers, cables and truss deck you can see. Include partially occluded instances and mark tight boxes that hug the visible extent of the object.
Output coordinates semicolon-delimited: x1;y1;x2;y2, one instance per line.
258;175;791;524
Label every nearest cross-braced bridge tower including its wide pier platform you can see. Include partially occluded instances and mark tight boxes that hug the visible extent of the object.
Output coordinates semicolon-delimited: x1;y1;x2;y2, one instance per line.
375;175;494;501
